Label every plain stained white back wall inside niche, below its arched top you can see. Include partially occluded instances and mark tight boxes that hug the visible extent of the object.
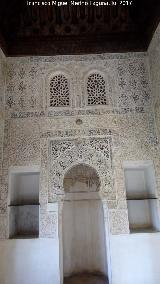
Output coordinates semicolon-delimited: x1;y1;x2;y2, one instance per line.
62;200;107;276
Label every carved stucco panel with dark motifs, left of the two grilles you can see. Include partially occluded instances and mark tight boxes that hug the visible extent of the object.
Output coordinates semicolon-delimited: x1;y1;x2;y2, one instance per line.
6;61;43;111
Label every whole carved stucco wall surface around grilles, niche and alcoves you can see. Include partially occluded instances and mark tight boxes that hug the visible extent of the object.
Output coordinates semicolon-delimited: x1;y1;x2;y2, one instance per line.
0;50;160;238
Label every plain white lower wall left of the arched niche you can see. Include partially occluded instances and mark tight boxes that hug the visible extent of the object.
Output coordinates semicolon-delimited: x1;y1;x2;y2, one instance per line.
0;239;60;284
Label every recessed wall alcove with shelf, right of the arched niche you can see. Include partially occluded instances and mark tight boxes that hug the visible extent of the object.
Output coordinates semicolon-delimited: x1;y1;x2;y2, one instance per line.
124;161;160;232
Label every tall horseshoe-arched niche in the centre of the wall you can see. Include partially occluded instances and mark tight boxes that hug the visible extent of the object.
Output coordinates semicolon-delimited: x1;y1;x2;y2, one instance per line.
62;164;108;284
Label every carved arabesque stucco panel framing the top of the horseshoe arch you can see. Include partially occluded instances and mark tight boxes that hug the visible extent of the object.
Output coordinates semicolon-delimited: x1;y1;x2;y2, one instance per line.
49;137;114;202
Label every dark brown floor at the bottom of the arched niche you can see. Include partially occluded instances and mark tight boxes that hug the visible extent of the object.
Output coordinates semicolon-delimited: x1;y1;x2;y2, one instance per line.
64;274;108;284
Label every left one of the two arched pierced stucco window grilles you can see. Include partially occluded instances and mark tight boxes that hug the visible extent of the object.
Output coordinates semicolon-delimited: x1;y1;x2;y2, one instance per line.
50;75;69;107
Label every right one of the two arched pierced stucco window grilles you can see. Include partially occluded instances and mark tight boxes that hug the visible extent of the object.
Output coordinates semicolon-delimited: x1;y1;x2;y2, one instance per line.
87;73;108;105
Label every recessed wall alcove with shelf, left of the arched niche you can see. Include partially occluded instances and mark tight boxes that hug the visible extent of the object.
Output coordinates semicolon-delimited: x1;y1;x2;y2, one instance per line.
8;167;40;238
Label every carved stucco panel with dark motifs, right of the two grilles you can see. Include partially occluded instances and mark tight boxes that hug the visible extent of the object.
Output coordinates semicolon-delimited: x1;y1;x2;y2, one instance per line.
117;60;151;113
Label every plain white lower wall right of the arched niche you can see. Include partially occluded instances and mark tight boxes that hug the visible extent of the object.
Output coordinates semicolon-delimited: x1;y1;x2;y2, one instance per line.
110;233;160;284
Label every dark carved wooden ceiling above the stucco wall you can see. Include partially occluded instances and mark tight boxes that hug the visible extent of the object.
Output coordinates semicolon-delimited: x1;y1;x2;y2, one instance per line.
0;0;160;56
